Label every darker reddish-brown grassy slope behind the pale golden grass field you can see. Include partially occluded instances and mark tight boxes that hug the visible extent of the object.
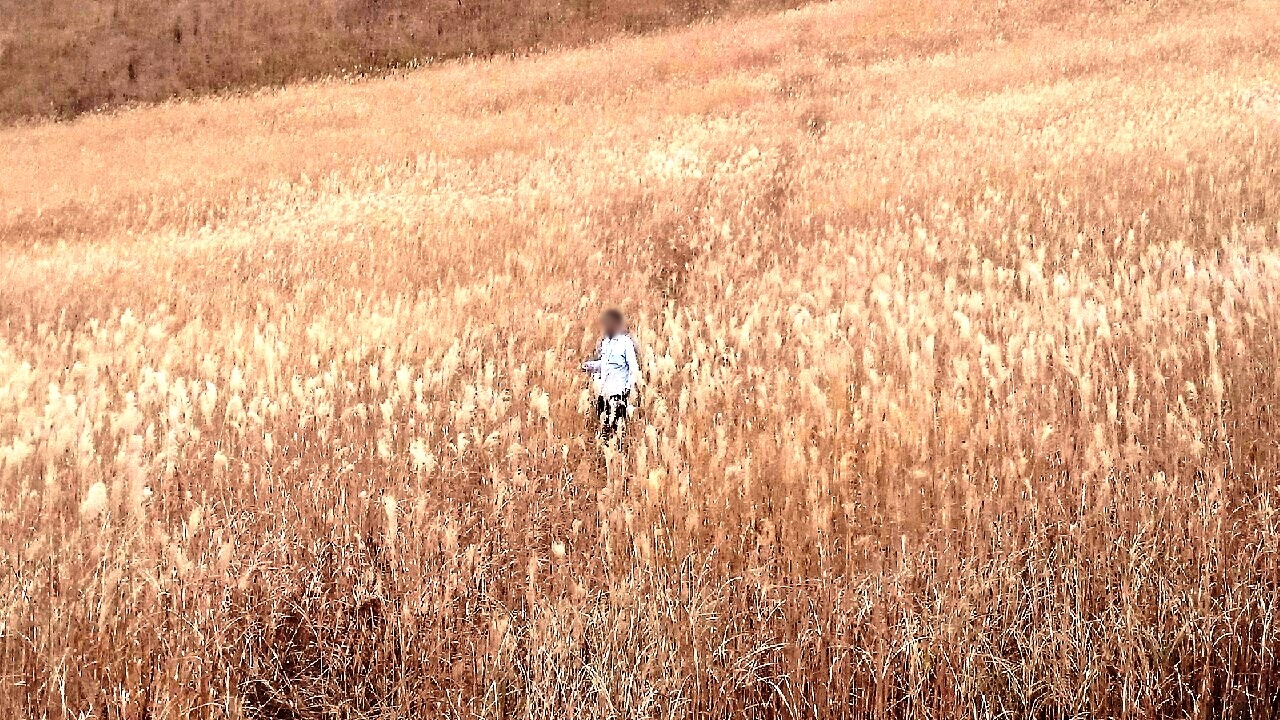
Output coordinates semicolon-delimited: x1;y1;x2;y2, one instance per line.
0;0;785;120
